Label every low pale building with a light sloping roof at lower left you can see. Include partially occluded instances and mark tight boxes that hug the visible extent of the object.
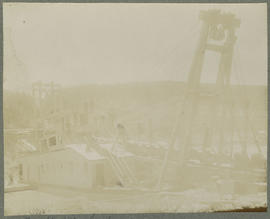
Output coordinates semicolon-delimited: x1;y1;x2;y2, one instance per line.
16;144;119;189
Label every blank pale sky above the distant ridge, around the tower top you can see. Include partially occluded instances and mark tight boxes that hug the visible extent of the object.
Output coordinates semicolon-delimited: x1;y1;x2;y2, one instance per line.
3;3;267;89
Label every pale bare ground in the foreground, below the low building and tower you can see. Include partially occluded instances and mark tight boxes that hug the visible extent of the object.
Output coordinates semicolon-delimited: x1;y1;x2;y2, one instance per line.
5;188;266;215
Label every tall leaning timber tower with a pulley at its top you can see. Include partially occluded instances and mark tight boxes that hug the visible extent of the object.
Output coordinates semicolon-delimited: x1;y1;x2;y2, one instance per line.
158;10;240;186
